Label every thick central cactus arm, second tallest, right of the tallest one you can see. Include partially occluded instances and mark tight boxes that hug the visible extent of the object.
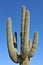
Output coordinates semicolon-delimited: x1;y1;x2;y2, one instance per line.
24;10;30;53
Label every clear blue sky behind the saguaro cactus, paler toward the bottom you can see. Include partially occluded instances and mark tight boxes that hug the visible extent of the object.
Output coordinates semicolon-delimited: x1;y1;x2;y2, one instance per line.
0;0;43;65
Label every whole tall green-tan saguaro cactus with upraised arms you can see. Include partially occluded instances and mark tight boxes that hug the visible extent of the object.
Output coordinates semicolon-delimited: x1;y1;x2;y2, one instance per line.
7;6;38;65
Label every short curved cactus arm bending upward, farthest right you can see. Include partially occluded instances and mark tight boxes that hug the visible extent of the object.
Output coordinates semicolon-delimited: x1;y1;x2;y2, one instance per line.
28;32;38;57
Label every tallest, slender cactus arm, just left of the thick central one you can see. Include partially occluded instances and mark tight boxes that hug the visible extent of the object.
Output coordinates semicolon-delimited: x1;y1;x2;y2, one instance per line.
21;6;25;56
